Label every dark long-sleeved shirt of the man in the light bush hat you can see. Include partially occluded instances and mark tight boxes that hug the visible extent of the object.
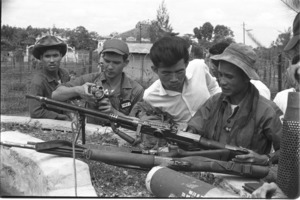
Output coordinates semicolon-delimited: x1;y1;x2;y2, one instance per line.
189;85;282;160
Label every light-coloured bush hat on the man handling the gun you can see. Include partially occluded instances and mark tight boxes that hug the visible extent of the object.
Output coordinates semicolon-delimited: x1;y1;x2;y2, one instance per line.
211;43;260;80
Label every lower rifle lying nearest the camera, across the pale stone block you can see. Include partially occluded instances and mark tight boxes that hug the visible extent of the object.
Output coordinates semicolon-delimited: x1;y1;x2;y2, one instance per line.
0;140;269;178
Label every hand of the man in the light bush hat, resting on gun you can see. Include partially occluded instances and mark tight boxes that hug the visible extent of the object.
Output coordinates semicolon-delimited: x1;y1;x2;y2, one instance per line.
232;149;269;165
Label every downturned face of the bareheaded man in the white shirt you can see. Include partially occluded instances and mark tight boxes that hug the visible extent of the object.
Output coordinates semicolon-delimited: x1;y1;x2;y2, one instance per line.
152;59;187;92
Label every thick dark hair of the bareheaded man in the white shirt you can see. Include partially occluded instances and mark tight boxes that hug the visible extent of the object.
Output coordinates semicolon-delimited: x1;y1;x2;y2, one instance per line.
150;36;189;67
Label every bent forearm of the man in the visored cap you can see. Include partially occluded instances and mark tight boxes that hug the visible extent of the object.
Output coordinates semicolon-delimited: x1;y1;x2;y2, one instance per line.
52;86;81;101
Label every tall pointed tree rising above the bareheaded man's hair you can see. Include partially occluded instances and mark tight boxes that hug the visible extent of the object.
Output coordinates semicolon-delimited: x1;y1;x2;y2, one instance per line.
149;0;178;42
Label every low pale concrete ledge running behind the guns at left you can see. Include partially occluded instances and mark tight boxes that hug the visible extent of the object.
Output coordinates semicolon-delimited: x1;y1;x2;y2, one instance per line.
1;115;136;146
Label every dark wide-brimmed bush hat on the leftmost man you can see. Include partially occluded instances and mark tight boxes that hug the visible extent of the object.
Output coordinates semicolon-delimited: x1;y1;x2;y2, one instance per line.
32;35;67;60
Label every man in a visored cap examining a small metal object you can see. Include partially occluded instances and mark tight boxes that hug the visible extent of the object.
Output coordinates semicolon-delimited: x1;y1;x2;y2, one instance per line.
52;39;144;124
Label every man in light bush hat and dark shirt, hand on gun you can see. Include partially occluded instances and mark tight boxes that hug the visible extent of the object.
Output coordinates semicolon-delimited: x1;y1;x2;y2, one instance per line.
189;43;282;165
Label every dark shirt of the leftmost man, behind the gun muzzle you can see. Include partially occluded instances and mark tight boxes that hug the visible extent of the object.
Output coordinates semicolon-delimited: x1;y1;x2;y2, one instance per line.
28;68;70;119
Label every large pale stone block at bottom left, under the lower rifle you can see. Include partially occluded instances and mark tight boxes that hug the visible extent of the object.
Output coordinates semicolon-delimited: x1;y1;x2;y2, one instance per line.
0;130;97;197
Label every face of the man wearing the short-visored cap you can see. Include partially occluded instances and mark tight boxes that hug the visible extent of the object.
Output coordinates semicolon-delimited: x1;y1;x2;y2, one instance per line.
103;53;128;78
